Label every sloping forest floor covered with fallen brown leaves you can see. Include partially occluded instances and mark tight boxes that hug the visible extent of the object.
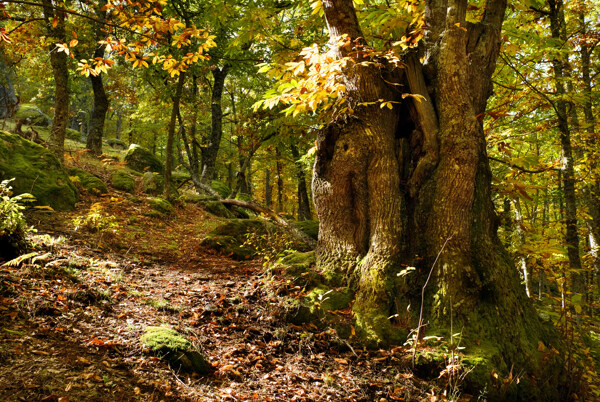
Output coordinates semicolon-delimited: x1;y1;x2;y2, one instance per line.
0;162;460;401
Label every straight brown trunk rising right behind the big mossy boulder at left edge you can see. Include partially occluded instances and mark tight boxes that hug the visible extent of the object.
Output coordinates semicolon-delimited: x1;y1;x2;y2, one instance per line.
42;0;69;162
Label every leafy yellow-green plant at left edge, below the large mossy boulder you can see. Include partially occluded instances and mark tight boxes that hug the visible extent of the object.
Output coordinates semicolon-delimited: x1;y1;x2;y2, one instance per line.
0;179;35;259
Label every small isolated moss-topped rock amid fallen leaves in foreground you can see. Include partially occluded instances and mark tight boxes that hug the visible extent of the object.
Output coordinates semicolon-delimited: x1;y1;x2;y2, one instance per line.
141;327;210;375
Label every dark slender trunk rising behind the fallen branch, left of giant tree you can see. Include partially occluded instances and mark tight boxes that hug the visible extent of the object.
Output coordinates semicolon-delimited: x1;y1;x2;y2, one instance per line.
201;64;229;184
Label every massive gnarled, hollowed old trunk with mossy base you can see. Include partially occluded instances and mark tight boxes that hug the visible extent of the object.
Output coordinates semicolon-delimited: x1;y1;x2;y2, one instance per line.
313;0;564;392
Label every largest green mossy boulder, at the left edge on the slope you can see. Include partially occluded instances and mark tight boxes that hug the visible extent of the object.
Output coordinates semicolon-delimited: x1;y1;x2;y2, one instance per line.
0;131;77;210
